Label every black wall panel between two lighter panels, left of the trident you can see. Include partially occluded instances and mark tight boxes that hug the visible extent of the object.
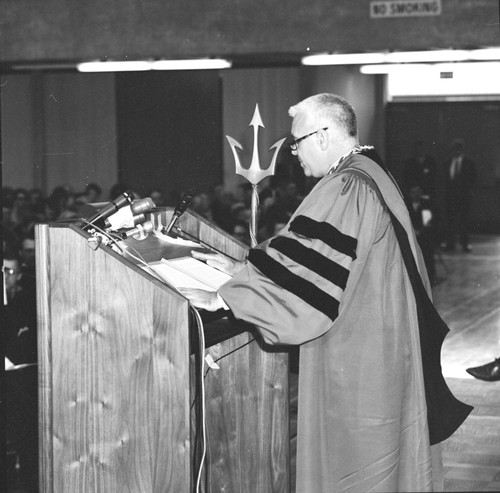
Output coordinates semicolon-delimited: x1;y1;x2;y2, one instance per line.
116;71;222;201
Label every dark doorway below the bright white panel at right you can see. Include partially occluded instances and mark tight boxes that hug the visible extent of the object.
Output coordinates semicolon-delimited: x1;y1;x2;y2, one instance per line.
386;101;500;234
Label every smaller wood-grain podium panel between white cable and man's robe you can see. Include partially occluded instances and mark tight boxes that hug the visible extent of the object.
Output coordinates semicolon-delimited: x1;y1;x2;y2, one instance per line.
205;333;290;493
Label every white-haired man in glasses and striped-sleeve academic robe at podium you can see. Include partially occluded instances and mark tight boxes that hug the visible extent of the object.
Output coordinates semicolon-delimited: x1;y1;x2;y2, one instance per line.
182;94;470;493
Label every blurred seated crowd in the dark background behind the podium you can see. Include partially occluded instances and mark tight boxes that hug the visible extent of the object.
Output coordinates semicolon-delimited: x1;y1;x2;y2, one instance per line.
2;175;303;492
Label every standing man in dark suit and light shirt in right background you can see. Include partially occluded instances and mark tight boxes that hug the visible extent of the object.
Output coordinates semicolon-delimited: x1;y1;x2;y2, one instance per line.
444;139;477;252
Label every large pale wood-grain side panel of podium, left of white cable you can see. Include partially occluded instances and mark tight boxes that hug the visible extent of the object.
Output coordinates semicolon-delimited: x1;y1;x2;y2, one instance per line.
37;228;190;492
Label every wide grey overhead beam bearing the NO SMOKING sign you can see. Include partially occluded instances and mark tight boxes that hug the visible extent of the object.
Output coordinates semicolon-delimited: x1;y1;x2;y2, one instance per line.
2;0;499;61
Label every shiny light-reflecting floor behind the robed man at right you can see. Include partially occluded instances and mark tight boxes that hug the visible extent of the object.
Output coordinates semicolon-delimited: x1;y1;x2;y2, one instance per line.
290;236;500;492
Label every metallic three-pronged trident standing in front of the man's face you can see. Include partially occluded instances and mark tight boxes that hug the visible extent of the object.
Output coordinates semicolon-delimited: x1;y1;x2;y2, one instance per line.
226;104;286;247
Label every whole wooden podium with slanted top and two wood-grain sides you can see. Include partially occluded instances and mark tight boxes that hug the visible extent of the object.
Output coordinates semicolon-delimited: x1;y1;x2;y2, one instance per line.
36;208;290;493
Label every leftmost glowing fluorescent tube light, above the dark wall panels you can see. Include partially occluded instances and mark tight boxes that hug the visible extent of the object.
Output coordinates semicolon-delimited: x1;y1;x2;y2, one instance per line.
77;58;231;72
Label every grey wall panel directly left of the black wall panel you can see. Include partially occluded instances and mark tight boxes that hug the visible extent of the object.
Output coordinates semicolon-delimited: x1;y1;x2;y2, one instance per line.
40;73;117;196
